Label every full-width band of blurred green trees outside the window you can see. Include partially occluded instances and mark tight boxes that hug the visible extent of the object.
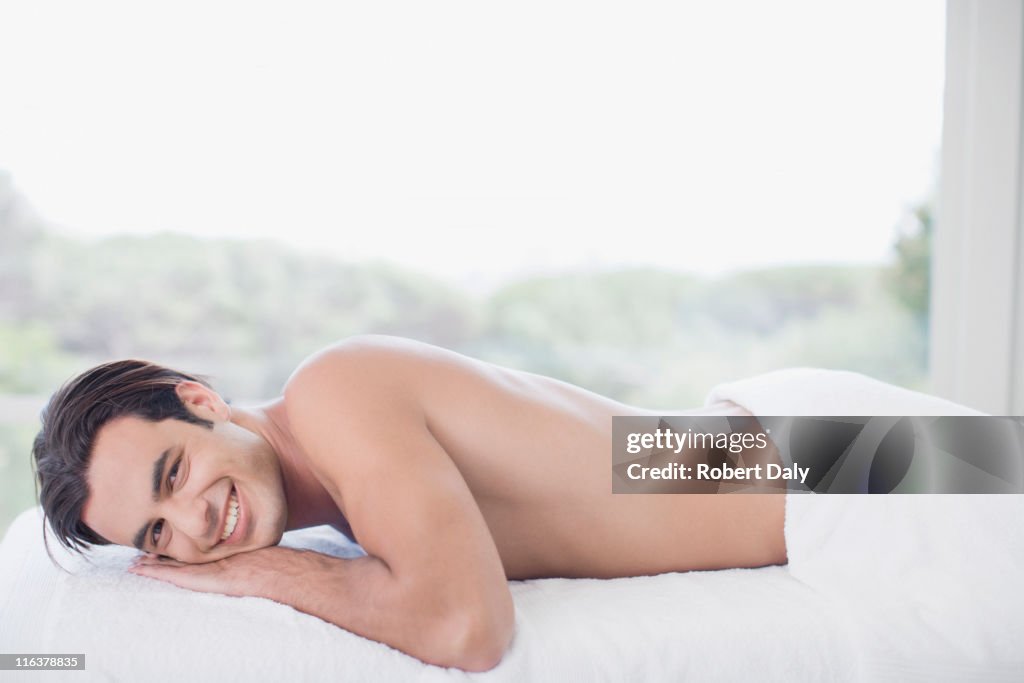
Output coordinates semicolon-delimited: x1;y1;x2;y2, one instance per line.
0;174;931;540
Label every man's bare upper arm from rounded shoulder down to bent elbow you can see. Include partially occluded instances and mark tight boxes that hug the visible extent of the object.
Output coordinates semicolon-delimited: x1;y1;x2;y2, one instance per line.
278;342;515;670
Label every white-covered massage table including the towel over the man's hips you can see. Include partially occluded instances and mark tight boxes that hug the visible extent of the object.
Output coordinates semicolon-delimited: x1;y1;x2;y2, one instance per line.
0;369;1024;683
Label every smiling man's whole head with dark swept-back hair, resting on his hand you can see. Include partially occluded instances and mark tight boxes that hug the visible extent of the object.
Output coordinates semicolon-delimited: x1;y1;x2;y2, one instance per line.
33;360;287;562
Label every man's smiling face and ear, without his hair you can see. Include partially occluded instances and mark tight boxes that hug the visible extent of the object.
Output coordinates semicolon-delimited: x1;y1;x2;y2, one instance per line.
82;385;288;562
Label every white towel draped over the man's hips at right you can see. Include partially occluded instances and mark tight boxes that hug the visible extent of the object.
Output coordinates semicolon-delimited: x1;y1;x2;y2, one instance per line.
707;368;1024;681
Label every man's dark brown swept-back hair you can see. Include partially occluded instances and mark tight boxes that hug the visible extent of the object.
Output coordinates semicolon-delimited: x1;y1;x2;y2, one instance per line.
32;360;213;558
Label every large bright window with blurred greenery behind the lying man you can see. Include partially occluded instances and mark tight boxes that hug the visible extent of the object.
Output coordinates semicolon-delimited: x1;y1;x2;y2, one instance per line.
0;0;962;540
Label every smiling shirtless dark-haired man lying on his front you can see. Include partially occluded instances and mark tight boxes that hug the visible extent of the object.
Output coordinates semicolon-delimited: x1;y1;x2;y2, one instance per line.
34;336;786;671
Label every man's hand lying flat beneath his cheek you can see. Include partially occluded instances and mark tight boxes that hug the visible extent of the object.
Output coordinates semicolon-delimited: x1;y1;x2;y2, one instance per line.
129;546;319;602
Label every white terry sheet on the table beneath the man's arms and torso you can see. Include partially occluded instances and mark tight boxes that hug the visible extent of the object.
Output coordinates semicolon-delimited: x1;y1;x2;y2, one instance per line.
0;510;858;683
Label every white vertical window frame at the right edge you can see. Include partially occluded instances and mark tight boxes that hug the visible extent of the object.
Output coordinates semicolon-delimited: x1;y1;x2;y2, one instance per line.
929;0;1024;415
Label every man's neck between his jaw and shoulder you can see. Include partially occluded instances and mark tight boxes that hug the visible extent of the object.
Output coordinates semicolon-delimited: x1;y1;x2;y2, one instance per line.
231;398;344;531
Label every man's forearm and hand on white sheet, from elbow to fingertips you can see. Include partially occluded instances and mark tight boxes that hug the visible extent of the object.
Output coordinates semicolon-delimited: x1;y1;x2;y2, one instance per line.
130;546;515;671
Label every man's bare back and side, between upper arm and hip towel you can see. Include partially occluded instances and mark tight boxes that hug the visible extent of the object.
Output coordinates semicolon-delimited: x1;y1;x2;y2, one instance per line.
280;338;785;579
